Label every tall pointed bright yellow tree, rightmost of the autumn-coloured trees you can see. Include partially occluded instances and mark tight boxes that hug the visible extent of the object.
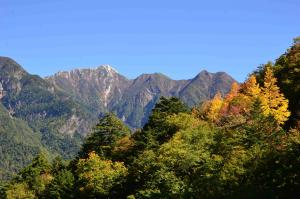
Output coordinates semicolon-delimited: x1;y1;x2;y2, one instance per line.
260;67;291;124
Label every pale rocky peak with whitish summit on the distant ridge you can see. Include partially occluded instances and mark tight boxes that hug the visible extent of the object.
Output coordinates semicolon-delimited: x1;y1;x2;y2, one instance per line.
46;65;130;112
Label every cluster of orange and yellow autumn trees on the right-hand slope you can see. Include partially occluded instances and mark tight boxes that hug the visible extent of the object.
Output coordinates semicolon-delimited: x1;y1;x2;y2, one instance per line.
198;67;290;125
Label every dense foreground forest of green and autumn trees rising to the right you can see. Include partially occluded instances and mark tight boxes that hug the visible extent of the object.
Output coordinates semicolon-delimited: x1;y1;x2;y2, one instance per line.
0;38;300;199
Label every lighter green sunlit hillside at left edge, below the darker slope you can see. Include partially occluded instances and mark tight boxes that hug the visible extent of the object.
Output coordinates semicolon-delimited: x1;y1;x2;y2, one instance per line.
0;104;45;179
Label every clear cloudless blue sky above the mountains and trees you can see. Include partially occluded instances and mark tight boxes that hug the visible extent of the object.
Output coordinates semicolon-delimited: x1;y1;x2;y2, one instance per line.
0;0;300;81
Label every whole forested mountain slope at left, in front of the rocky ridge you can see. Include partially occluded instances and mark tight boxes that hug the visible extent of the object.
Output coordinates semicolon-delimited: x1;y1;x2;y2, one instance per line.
0;57;96;180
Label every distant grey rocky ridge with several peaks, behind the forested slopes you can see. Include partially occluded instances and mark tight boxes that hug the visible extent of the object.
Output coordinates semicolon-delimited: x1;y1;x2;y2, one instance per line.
46;65;235;128
